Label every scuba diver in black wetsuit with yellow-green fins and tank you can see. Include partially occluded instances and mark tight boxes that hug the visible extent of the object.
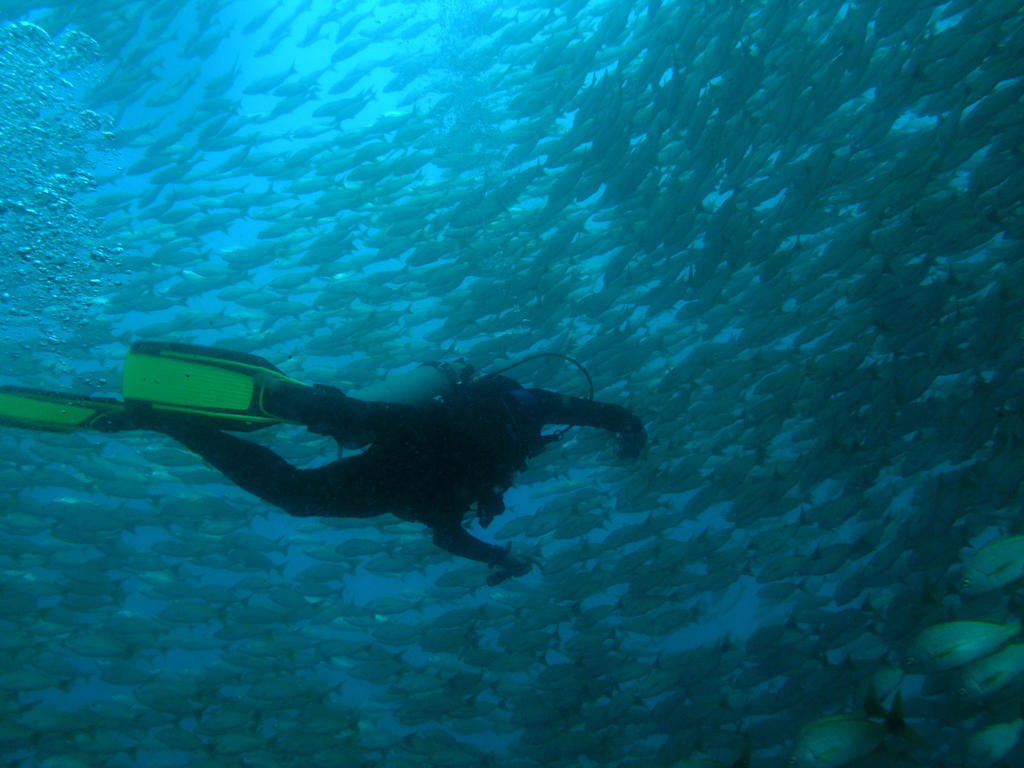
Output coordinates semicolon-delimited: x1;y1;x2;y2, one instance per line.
0;341;646;585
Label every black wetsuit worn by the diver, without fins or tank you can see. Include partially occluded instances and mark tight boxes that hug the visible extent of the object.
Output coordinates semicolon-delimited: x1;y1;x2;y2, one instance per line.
153;376;644;565
